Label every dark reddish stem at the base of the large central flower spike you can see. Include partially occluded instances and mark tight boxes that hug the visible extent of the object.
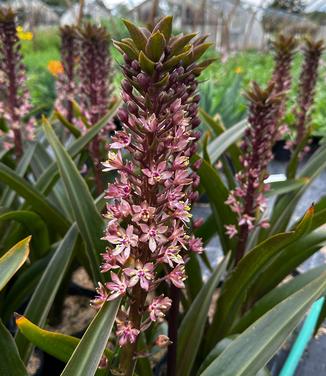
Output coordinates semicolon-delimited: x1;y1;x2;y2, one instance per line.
119;285;147;376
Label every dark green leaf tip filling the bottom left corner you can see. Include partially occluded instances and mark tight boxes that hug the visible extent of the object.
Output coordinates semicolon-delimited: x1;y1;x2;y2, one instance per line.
0;320;28;376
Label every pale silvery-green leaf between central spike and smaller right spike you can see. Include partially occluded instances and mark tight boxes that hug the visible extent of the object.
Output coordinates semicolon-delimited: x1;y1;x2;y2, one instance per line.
208;119;248;163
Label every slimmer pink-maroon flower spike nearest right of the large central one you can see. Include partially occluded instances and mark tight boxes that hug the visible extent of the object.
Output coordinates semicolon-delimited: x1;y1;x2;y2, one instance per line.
226;82;283;263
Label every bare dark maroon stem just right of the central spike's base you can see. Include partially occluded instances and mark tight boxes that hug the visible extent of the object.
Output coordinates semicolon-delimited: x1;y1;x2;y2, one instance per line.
167;285;180;376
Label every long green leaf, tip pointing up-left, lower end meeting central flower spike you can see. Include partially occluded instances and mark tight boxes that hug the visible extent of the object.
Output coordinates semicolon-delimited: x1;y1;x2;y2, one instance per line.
43;121;104;281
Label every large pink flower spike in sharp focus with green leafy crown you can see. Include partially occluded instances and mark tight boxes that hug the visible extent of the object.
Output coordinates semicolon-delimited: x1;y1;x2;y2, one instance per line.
93;17;213;375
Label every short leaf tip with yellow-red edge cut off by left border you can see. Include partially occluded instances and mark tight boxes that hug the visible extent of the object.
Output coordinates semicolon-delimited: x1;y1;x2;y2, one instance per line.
0;236;31;291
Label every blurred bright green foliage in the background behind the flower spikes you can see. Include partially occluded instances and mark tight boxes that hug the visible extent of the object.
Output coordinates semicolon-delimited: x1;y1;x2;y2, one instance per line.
22;20;326;136
